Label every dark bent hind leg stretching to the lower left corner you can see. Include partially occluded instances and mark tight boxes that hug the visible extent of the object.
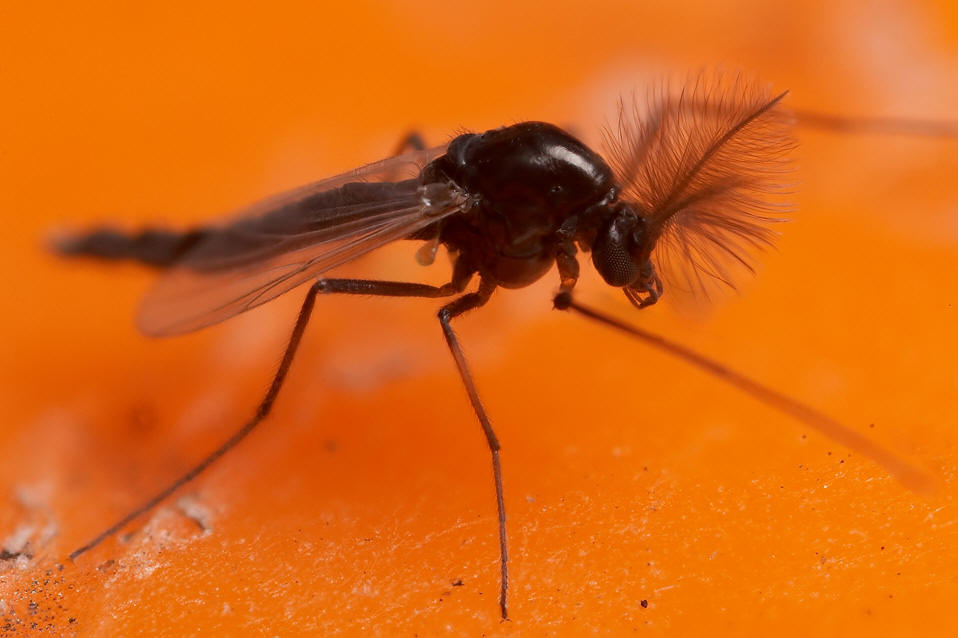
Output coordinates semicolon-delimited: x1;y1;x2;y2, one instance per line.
70;276;468;560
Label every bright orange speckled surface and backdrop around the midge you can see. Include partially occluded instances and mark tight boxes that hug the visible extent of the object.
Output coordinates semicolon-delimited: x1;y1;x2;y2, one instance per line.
0;0;958;637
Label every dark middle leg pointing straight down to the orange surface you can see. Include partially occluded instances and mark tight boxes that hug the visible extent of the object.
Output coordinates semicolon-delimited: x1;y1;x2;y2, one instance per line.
439;281;509;620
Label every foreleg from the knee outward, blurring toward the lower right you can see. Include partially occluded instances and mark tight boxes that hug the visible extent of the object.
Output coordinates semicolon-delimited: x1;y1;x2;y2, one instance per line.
553;292;932;491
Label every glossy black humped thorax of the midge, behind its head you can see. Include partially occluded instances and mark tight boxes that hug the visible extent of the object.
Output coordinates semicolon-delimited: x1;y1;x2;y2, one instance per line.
423;122;617;288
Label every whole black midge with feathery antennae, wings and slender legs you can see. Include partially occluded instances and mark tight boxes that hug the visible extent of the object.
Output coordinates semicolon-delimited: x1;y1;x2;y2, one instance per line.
57;76;944;619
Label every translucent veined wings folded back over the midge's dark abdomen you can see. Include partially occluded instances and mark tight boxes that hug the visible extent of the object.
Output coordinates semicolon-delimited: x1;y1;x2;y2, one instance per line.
137;148;465;336
